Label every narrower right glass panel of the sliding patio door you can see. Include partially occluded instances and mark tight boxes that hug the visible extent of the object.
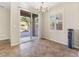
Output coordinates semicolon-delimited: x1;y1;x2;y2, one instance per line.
32;13;38;40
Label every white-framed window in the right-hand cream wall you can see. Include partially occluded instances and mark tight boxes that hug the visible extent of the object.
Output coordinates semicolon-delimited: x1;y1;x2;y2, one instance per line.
50;13;63;30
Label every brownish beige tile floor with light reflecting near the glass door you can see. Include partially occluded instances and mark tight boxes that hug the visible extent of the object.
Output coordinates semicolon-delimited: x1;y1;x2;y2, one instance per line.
0;39;79;57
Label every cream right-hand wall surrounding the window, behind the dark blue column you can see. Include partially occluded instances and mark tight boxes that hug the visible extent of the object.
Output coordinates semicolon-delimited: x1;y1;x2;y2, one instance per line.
43;3;79;45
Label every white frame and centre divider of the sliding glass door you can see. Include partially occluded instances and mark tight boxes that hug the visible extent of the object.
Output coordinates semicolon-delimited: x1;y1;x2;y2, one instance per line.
19;7;41;41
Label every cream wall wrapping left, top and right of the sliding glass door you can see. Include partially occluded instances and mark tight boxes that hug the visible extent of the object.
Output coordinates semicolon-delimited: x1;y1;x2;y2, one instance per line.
10;2;41;47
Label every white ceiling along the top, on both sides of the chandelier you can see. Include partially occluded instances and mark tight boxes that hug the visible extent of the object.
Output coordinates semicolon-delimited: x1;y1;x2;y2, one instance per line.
0;2;58;9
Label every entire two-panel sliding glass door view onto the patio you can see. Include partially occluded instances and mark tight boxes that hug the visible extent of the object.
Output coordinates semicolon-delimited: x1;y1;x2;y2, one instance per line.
20;10;38;43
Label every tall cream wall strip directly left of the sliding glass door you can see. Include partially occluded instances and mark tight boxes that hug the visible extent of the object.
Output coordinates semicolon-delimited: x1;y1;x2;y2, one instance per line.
10;3;20;46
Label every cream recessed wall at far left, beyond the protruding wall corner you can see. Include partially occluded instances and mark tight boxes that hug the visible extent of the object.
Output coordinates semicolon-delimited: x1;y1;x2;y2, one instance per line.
0;8;10;40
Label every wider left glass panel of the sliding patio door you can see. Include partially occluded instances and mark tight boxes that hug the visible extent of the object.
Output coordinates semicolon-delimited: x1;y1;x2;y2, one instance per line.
20;10;31;43
